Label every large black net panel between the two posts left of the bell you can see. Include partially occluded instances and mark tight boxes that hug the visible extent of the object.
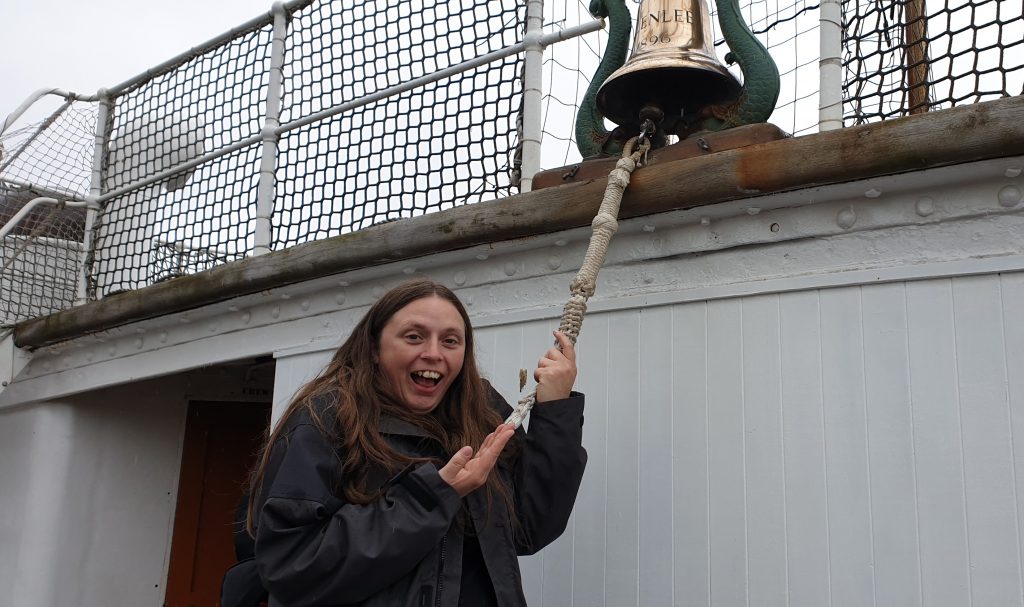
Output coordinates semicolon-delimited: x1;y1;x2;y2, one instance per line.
273;0;524;249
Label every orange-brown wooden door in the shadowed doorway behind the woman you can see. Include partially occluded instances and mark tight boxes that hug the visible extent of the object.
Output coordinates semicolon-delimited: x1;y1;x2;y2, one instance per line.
164;401;270;607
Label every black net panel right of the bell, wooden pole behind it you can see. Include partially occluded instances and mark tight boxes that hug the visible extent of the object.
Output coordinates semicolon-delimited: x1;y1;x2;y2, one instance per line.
843;0;1024;126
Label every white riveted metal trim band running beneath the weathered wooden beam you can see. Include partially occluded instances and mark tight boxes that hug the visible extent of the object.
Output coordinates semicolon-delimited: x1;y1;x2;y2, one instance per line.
0;159;1024;407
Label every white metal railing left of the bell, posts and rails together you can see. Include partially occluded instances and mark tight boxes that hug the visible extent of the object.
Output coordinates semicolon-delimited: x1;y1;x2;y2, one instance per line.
0;0;604;323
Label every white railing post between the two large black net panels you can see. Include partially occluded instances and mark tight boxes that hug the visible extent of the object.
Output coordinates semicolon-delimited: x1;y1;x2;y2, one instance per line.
252;2;288;256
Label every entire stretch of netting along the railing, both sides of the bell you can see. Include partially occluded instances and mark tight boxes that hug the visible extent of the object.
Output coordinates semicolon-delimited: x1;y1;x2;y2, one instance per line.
0;0;1024;324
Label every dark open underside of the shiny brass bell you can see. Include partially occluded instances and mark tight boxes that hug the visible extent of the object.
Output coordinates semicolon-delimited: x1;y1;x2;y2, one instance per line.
597;62;742;126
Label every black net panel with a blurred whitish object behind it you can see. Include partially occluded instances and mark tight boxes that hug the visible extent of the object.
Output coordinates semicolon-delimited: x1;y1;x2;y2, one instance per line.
89;25;272;297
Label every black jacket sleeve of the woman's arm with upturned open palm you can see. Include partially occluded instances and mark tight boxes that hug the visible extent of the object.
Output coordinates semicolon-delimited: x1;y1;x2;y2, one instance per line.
256;424;461;607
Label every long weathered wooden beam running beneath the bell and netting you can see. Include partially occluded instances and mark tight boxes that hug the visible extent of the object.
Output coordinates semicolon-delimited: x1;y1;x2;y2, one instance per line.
14;96;1024;348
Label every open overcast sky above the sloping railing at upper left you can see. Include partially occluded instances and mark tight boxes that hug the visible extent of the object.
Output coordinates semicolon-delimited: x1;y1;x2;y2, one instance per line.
0;0;272;124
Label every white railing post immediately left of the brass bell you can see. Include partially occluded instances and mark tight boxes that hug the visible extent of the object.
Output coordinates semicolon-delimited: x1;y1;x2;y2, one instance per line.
519;0;544;191
